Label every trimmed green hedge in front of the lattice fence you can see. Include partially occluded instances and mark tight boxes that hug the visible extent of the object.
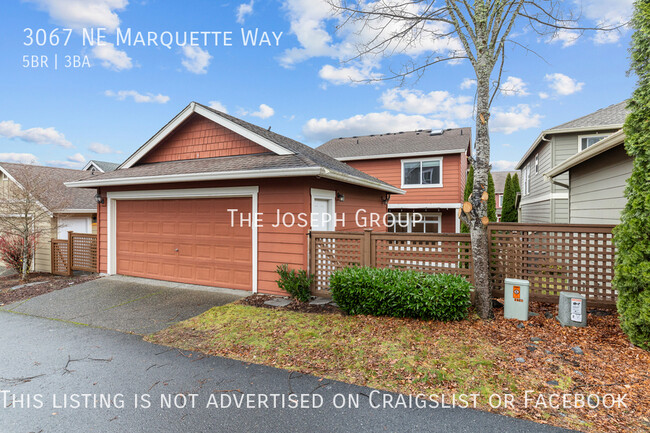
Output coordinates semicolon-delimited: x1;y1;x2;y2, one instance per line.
330;267;471;321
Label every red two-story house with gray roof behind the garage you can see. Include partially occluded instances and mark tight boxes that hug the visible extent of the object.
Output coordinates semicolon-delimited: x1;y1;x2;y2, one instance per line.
318;128;471;233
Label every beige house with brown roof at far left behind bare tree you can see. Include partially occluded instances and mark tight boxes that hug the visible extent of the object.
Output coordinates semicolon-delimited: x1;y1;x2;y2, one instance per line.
0;162;97;272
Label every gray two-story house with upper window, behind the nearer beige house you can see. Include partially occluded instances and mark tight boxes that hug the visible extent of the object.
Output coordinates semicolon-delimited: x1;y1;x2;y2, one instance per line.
515;101;627;223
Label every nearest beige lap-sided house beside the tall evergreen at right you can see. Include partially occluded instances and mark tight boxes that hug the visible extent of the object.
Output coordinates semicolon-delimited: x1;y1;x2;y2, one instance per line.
544;130;633;224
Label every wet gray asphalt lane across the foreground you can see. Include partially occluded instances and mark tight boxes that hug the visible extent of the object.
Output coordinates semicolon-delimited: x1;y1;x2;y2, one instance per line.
0;311;562;433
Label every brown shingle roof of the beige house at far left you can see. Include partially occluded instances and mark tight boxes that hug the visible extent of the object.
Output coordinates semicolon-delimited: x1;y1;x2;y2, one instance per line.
0;162;97;213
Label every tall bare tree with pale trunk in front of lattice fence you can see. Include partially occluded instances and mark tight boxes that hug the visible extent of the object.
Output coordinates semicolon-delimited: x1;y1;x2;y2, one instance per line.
327;0;620;318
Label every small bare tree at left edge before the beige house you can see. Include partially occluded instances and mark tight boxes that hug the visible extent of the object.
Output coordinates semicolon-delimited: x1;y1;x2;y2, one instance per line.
0;164;68;280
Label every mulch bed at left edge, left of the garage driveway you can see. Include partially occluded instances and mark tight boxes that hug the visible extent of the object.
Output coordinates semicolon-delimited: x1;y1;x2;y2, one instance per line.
0;272;99;306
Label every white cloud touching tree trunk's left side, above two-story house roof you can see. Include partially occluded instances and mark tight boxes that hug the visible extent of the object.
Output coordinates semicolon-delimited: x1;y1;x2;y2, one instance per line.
381;89;474;119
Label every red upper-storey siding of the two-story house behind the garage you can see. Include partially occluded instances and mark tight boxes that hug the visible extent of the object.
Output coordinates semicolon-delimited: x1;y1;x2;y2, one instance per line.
346;154;467;204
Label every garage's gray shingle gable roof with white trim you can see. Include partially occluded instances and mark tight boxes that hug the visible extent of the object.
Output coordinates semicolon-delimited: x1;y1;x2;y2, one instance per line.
67;102;404;194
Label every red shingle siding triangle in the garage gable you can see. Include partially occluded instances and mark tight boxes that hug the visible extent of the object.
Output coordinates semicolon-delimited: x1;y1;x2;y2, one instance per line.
138;115;269;165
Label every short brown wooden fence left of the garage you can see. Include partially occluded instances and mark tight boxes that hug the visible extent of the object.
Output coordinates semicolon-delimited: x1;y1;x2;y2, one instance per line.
52;232;97;275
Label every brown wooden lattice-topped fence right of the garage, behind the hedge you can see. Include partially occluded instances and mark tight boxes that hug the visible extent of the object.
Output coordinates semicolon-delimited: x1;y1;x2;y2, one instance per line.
309;223;616;307
